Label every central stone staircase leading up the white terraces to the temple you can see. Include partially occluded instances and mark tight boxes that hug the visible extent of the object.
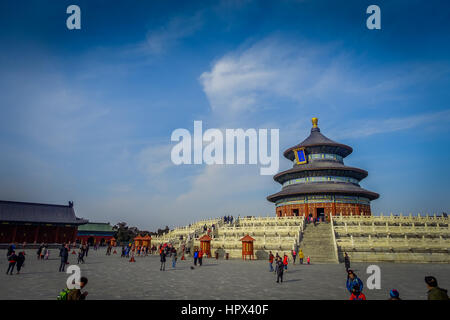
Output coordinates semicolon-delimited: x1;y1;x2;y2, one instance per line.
300;223;338;264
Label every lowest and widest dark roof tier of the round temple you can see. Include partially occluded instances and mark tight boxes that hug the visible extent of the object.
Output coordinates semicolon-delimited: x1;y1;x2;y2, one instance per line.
267;183;380;202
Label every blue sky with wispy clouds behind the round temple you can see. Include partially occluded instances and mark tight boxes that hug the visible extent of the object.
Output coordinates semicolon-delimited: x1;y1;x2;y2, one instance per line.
0;0;450;229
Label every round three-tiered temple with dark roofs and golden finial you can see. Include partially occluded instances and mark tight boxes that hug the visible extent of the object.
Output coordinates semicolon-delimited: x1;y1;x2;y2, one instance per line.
267;118;379;220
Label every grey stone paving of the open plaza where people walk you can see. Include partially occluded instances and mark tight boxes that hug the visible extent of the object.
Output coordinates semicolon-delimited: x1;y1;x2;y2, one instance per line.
0;249;450;300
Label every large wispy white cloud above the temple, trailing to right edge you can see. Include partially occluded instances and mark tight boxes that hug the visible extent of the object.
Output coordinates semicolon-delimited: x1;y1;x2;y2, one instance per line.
199;36;450;117
